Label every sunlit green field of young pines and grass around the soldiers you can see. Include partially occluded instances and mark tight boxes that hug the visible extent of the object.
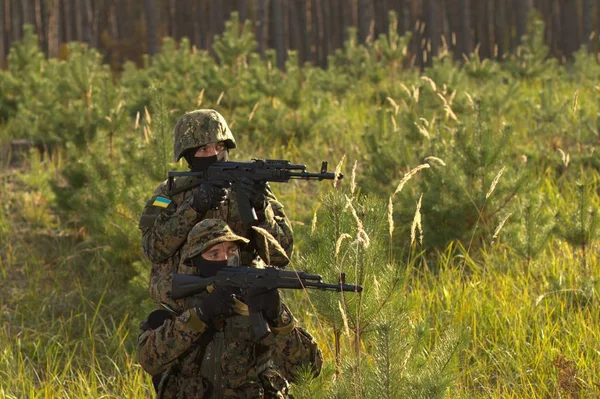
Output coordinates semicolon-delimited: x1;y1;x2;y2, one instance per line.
0;3;600;398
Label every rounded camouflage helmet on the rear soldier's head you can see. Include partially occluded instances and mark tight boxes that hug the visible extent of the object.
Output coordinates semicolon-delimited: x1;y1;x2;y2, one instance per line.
173;109;236;162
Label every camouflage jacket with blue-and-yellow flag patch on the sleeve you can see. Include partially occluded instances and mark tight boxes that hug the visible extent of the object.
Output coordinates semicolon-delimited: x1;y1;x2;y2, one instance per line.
139;177;294;303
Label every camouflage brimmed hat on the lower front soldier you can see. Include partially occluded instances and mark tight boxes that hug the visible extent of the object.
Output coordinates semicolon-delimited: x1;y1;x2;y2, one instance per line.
181;219;249;261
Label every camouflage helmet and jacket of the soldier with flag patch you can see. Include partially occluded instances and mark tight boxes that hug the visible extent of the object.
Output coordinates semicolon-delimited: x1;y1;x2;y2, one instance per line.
139;109;293;302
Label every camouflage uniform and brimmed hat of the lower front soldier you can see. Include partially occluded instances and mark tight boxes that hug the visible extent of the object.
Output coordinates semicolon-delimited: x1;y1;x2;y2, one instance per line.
138;219;323;399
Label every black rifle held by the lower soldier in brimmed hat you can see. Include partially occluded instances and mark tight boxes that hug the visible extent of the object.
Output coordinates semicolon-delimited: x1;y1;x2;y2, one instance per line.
171;267;363;341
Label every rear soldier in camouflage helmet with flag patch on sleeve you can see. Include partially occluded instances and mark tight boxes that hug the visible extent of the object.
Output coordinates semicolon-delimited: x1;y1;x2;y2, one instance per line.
139;109;293;303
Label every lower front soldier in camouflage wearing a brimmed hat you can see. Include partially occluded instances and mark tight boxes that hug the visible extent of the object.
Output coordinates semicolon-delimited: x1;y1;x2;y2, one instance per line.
138;219;323;399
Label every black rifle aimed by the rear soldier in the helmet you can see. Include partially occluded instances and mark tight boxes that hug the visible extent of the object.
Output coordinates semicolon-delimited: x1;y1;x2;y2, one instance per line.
167;159;344;228
